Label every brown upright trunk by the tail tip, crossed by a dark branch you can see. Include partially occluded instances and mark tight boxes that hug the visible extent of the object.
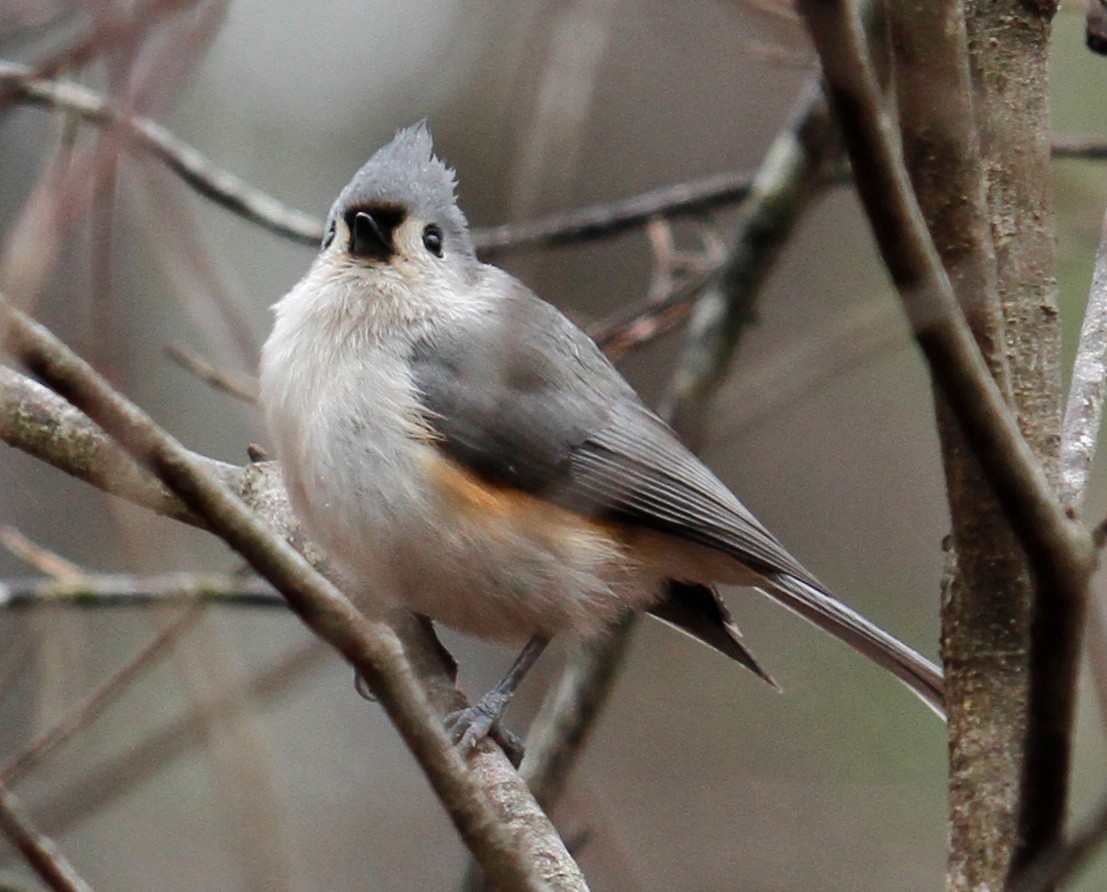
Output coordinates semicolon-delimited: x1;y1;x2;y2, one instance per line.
888;0;1032;892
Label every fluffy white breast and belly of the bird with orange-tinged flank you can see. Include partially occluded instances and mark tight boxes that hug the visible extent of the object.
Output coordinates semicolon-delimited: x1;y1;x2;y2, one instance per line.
260;258;660;639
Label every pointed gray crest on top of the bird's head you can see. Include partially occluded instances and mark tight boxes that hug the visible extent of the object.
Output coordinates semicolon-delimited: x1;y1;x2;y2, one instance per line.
329;121;473;255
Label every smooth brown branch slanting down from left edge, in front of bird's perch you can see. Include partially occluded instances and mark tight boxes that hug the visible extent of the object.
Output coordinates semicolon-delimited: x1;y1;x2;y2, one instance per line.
0;300;586;890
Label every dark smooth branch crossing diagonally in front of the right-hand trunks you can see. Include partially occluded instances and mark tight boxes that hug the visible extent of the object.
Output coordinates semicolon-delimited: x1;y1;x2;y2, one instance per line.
800;0;1095;867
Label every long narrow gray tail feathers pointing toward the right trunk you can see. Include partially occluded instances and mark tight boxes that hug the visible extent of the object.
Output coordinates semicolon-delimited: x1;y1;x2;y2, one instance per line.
761;573;945;720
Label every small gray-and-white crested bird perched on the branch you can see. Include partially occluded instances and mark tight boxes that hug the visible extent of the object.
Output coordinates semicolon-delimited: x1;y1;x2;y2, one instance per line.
260;124;942;745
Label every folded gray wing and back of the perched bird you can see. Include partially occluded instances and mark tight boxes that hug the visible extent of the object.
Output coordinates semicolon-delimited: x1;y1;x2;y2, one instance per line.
411;277;818;585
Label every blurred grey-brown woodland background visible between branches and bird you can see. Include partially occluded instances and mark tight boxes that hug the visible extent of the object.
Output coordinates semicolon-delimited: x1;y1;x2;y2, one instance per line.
0;0;1107;892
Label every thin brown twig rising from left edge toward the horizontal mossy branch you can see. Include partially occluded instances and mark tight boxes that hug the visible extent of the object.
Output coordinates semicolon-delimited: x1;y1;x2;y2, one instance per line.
0;609;201;787
